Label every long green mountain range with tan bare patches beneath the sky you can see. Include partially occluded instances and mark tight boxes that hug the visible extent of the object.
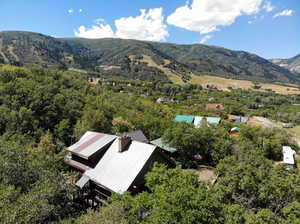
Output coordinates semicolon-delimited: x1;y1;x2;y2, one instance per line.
0;31;300;84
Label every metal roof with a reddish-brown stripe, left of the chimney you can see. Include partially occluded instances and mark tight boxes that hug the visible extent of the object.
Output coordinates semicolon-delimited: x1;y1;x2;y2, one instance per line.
68;131;117;159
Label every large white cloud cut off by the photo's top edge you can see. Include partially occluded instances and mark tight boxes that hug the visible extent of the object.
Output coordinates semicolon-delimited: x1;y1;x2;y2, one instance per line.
167;0;263;34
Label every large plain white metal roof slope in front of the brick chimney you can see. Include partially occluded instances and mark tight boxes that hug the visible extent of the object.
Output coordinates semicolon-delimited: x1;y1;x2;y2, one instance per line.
84;140;156;194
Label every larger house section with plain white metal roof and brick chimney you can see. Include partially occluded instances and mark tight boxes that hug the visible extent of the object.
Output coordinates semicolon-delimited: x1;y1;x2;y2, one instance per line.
69;136;173;202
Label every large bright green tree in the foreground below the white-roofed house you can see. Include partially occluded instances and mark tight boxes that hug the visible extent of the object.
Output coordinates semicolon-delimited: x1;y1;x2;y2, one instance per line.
79;166;223;224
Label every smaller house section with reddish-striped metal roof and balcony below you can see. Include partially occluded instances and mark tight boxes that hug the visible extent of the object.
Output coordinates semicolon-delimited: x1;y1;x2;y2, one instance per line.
65;131;117;172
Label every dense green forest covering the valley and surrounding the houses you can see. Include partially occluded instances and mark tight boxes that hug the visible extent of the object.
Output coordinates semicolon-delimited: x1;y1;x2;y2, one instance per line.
0;65;300;224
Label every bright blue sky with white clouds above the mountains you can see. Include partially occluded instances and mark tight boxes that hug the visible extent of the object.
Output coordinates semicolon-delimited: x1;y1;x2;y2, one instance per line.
0;0;300;58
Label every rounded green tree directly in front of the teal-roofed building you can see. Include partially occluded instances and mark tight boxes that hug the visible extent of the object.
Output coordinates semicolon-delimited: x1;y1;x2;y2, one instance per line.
163;122;232;167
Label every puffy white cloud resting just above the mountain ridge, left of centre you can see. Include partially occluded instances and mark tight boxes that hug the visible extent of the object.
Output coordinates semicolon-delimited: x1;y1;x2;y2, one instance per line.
75;8;169;41
